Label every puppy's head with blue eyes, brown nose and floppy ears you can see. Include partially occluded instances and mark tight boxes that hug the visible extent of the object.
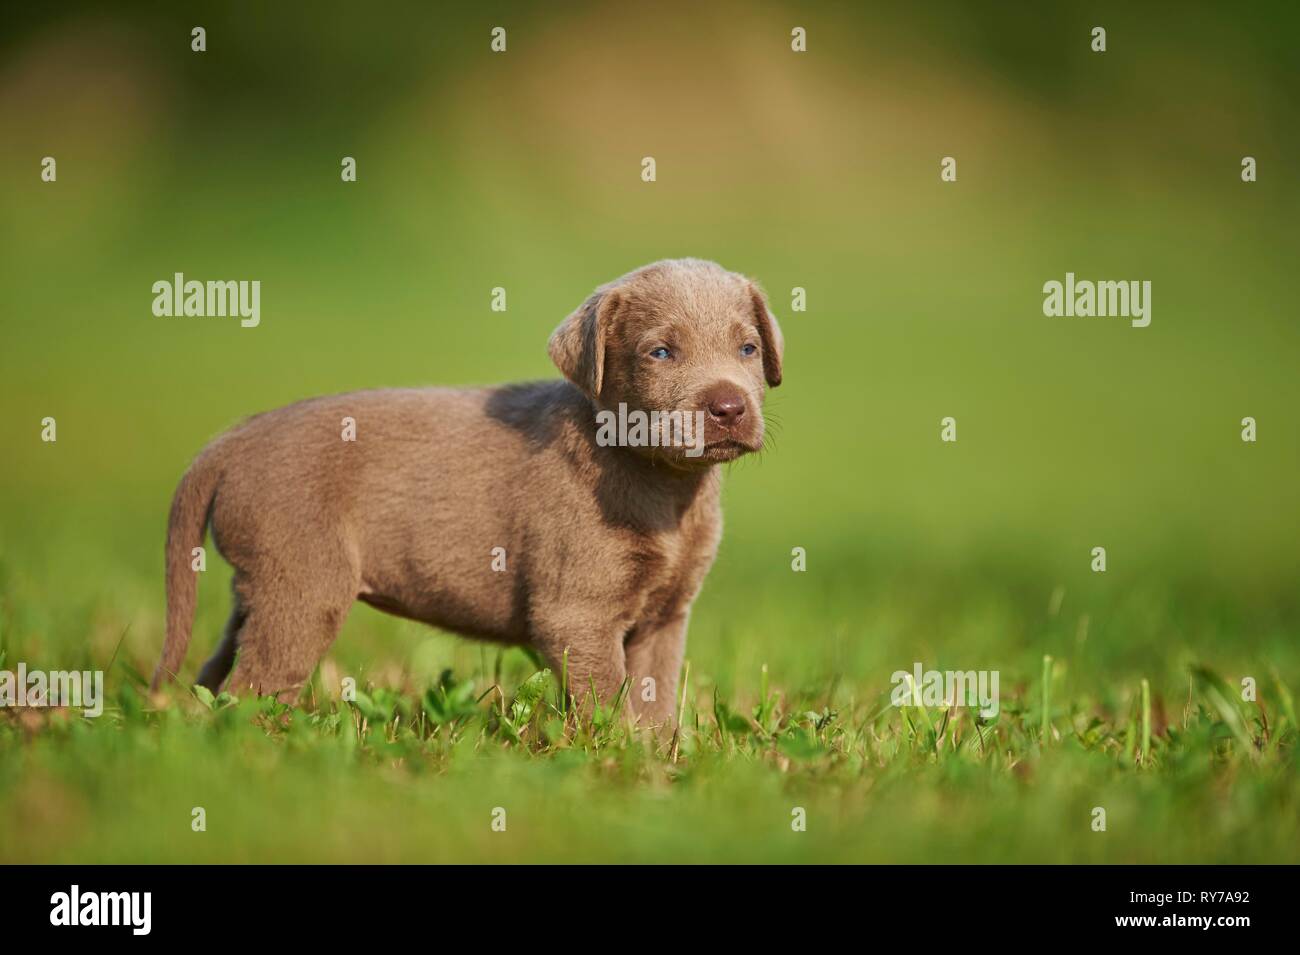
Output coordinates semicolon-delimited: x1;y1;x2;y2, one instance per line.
549;259;784;466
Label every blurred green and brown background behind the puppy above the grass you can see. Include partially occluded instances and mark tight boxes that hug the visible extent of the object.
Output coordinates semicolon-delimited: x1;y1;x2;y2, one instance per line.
0;3;1300;867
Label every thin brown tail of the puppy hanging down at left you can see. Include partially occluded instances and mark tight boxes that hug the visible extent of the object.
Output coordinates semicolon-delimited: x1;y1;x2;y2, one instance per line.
152;451;221;690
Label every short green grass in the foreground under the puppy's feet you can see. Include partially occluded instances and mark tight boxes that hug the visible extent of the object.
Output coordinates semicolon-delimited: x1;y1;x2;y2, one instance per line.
0;571;1300;863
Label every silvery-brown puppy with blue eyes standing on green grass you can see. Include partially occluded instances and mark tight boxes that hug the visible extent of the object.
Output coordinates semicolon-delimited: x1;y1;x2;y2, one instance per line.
153;259;783;722
